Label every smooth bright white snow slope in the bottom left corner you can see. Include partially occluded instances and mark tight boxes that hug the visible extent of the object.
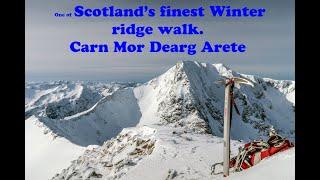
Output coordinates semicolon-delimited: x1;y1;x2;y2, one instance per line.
25;116;85;180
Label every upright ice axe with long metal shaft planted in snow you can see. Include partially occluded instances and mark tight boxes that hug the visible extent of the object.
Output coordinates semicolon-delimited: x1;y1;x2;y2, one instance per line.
216;77;254;177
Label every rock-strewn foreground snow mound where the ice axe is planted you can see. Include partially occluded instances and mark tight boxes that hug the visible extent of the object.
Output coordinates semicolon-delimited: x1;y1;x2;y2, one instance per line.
53;126;295;180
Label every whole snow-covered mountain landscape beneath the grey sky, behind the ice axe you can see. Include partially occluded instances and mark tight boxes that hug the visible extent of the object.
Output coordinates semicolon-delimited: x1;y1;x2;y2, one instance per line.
25;61;295;179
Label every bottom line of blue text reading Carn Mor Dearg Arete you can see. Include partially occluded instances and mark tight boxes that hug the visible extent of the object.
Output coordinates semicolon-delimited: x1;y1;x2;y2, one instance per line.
70;41;247;55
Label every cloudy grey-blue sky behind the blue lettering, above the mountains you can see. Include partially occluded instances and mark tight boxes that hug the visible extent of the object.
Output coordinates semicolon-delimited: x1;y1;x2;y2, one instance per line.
25;0;295;82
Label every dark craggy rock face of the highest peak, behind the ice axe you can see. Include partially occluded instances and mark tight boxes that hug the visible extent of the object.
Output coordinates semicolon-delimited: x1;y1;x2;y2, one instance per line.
158;62;294;141
